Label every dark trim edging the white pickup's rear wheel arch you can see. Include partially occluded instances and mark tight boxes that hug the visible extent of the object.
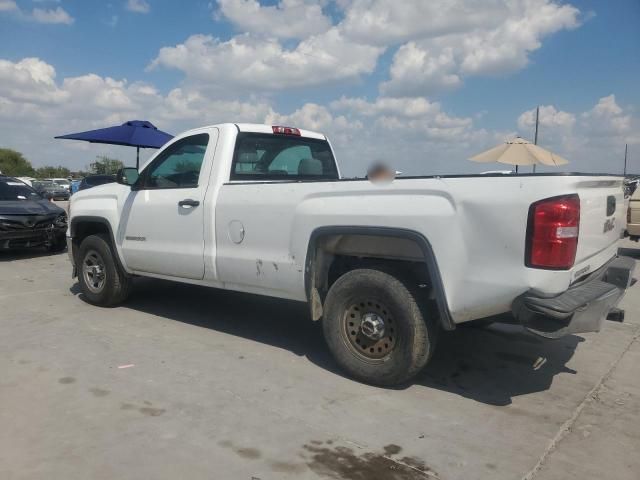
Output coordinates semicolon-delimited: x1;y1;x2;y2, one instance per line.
304;225;456;330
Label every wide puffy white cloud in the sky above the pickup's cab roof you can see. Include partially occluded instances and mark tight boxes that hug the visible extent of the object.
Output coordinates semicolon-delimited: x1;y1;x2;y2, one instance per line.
150;28;382;91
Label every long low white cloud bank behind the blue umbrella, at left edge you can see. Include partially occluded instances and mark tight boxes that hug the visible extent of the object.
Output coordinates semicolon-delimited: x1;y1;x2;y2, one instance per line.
0;58;280;168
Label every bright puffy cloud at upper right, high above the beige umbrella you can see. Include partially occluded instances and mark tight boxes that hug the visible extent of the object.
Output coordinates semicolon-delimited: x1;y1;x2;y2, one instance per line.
381;0;579;95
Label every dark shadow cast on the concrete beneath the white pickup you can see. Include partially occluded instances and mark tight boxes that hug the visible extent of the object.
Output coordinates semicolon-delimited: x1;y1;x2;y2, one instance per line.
87;278;583;405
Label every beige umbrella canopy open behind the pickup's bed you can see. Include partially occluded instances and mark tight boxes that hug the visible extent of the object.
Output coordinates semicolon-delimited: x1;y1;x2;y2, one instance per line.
470;137;569;172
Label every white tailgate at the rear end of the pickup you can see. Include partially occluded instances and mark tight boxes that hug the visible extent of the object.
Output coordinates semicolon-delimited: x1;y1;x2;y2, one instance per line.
574;177;626;272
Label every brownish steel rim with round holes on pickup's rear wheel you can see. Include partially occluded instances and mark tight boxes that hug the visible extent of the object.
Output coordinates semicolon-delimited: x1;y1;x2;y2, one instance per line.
342;299;398;362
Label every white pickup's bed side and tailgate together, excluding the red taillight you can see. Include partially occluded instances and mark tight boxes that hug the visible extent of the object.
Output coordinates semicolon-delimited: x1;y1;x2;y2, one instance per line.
216;175;622;322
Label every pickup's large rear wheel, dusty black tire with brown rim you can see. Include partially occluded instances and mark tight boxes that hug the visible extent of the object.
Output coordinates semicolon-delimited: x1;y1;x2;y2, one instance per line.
322;268;438;387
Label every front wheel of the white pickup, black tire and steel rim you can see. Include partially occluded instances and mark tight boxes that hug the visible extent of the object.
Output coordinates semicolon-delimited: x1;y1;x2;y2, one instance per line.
76;234;132;307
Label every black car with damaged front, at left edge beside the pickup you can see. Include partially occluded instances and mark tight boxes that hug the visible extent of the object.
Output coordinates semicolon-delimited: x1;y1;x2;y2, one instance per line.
0;175;67;251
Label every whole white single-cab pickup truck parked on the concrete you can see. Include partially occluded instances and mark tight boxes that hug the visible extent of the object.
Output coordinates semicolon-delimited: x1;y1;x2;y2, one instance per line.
67;124;634;385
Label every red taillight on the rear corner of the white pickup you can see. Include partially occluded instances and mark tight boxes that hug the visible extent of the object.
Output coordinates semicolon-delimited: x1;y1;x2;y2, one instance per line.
525;195;580;270
